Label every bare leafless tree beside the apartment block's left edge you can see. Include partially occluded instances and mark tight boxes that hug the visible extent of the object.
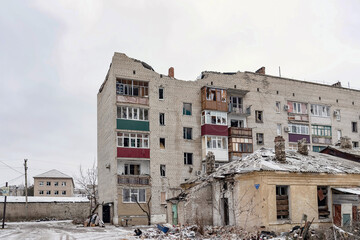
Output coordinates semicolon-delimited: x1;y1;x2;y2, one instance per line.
76;162;100;215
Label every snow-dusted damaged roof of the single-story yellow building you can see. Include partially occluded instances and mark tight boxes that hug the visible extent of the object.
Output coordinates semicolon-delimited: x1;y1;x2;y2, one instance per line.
213;148;360;177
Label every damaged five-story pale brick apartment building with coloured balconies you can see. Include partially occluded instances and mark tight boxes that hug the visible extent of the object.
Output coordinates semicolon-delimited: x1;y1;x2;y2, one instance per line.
97;53;360;225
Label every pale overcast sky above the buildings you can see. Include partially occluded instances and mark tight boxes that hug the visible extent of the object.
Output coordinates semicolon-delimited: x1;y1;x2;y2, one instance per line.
0;0;360;186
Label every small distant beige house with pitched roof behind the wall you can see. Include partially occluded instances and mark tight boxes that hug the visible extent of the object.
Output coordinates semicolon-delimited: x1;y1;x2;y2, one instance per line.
34;169;74;197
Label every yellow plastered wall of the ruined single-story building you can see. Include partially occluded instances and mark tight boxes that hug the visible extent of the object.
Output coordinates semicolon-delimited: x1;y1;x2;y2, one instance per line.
236;172;360;231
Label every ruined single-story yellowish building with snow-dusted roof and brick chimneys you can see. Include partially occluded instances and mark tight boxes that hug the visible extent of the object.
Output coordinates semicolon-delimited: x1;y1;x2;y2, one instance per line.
167;136;360;231
